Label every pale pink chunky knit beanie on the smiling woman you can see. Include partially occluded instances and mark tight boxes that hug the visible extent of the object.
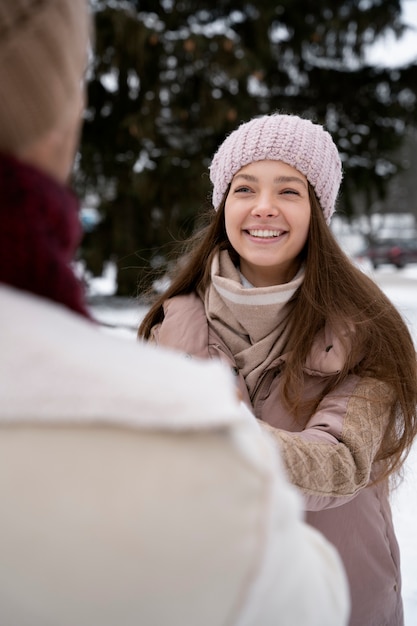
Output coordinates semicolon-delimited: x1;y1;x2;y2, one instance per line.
210;114;342;224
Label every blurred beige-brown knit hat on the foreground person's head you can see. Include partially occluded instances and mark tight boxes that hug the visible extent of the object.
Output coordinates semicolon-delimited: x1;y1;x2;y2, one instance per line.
0;0;91;153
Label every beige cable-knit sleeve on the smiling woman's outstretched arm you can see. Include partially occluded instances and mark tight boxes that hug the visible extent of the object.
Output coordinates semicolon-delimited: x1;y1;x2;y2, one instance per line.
262;378;393;511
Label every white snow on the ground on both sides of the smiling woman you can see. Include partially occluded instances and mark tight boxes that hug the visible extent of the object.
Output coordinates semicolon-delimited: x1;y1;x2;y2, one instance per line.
90;265;417;626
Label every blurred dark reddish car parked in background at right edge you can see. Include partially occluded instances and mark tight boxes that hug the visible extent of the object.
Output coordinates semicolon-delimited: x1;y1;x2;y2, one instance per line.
357;238;417;269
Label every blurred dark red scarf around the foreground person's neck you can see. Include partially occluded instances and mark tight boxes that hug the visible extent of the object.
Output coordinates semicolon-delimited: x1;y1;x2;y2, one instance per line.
0;154;90;317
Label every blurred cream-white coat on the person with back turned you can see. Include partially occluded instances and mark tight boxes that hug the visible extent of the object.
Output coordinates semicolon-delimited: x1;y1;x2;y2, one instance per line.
0;286;348;626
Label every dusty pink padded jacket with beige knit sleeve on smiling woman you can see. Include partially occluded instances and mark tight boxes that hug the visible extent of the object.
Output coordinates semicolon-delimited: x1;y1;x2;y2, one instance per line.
153;294;403;626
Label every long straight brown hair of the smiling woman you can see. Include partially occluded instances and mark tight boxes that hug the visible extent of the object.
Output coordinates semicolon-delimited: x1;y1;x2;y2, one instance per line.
138;185;417;477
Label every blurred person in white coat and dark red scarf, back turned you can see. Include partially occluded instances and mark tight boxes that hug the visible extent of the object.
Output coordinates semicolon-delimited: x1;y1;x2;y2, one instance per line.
0;0;348;626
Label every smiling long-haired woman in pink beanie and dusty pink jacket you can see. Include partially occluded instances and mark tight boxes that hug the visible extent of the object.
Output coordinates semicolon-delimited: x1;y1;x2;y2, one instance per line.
139;115;417;626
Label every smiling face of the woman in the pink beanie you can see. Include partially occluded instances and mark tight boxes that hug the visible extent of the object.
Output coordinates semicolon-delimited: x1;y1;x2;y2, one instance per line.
224;161;311;287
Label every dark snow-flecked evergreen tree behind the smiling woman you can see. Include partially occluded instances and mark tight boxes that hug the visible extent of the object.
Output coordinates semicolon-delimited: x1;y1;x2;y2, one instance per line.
75;0;417;296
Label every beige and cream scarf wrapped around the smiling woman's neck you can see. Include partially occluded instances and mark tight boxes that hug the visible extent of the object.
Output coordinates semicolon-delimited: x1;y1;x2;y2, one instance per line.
204;251;304;398
